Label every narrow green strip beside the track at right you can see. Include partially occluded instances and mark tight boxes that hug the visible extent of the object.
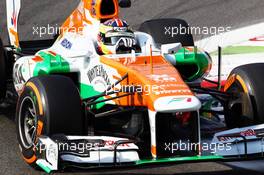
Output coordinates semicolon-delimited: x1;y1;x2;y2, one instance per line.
211;46;264;55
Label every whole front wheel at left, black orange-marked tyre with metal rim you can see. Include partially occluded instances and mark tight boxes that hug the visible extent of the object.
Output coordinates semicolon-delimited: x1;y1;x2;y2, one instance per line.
16;75;84;168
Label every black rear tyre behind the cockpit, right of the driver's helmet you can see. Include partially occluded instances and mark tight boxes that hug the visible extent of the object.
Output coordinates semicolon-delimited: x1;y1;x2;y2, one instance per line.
139;18;194;46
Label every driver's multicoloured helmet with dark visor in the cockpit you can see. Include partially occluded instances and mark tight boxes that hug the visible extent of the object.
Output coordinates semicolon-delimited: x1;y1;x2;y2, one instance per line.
98;18;136;55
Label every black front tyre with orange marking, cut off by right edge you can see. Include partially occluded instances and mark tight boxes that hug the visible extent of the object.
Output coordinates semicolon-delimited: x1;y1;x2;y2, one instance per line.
224;63;264;128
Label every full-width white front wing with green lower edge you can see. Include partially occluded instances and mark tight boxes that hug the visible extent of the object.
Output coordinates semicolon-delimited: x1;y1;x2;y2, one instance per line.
35;125;264;173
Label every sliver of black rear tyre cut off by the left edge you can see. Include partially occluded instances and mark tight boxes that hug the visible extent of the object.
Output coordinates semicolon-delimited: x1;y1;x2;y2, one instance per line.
0;38;6;101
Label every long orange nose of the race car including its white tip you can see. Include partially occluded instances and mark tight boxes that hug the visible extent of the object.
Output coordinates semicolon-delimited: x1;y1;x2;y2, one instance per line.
100;55;201;112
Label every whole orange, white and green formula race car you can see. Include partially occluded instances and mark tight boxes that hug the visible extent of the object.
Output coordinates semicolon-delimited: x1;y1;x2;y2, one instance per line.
0;0;264;173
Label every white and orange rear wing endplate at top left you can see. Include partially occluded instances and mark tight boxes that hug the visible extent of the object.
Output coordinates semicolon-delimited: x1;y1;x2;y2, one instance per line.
6;0;21;49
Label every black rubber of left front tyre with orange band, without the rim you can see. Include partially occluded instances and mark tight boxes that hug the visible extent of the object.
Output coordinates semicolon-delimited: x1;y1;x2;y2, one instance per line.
16;76;84;164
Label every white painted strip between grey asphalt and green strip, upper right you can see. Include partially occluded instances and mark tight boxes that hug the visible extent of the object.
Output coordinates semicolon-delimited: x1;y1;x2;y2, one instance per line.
195;23;264;52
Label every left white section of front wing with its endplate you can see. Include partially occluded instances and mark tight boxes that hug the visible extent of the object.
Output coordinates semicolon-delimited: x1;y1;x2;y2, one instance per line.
35;136;139;173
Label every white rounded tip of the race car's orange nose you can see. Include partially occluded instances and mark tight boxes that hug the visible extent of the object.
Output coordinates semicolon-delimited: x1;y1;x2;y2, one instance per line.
154;95;201;113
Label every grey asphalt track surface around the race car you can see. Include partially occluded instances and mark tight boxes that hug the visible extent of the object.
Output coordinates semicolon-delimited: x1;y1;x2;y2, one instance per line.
0;0;264;175
